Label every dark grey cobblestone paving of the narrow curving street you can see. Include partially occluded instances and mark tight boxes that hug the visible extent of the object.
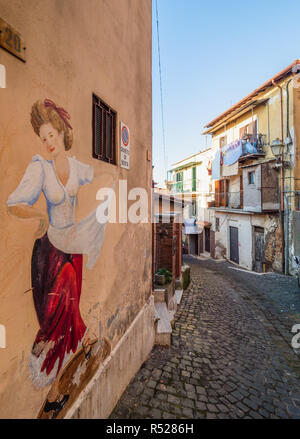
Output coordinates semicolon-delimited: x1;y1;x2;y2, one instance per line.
111;258;300;419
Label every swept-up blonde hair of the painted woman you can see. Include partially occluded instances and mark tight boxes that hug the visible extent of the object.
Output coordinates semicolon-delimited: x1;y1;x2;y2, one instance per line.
31;100;73;151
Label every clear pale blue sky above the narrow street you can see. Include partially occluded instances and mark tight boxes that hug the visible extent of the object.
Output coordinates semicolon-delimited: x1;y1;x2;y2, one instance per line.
152;0;300;186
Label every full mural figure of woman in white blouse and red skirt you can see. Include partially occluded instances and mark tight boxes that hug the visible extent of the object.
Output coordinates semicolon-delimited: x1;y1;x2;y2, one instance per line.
7;99;112;412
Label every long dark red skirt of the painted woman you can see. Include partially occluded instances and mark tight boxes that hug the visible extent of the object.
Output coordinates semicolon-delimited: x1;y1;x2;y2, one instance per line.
31;234;86;382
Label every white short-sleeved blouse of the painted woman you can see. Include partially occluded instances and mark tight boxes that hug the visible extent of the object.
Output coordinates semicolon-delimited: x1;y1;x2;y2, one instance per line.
7;155;111;269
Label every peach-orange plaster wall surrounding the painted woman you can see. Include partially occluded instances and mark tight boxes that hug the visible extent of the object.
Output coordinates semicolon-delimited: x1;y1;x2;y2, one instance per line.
0;0;152;418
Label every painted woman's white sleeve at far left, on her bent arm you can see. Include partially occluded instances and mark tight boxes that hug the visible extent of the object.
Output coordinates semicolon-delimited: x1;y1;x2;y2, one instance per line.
6;160;44;206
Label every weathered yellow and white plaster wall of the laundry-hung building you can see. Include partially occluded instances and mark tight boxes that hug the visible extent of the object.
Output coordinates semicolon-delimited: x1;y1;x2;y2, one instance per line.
206;75;300;274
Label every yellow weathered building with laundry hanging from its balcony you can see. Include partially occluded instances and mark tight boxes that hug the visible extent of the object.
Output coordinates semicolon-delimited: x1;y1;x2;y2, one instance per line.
204;60;300;274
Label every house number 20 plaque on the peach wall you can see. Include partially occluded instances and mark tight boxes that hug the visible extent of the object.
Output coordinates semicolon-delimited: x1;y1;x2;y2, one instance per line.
0;18;26;62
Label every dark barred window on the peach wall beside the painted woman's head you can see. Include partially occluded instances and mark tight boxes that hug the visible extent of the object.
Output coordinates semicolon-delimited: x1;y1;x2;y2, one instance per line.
93;95;117;165
